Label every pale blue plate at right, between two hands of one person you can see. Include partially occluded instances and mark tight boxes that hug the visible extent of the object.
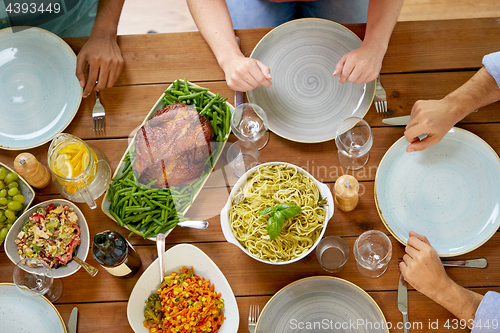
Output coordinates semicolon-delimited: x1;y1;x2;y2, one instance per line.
375;128;500;257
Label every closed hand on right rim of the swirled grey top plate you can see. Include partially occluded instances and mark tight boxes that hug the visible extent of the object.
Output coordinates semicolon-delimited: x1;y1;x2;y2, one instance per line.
333;45;384;84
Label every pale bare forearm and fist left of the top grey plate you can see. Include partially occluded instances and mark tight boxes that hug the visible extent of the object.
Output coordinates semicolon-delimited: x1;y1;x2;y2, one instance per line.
187;0;272;91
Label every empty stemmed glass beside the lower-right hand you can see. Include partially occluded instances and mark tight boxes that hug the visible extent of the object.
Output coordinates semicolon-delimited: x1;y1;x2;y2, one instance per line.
353;230;392;278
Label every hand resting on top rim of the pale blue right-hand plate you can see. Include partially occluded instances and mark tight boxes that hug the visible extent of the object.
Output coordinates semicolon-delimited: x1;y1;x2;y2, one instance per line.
404;99;460;153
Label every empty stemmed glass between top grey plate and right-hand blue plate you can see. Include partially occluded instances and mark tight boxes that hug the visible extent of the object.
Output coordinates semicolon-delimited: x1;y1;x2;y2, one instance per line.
335;117;373;170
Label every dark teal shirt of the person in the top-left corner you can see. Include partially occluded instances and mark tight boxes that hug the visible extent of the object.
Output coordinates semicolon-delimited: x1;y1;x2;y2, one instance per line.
0;0;99;38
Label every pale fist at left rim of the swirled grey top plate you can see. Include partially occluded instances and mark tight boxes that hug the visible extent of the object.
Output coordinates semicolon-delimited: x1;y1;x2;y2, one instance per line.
222;55;273;91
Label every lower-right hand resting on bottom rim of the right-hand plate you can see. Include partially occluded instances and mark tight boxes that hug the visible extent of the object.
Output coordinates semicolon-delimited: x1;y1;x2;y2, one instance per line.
399;231;453;299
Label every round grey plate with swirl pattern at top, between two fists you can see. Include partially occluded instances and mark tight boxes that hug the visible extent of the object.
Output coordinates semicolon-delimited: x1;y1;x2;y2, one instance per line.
247;18;375;142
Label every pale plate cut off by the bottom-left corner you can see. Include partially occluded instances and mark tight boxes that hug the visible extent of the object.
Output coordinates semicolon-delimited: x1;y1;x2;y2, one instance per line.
0;283;66;333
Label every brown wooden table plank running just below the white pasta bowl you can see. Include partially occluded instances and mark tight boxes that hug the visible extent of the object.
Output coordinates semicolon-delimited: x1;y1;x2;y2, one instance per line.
0;235;500;303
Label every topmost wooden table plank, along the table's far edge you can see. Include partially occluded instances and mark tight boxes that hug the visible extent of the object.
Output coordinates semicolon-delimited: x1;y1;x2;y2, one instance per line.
65;18;500;85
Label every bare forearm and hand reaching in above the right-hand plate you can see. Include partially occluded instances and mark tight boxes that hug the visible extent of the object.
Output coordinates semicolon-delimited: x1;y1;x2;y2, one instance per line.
405;67;500;152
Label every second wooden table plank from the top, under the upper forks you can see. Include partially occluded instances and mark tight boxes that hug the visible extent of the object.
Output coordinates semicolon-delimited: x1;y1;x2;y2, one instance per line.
0;71;492;145
